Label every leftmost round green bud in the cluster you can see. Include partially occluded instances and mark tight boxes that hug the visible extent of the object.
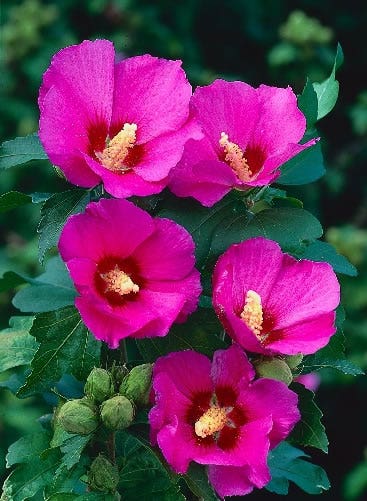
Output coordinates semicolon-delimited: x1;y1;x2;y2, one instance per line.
57;399;98;435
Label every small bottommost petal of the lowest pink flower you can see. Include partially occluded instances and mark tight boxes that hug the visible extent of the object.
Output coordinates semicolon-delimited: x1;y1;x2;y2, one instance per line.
208;465;258;498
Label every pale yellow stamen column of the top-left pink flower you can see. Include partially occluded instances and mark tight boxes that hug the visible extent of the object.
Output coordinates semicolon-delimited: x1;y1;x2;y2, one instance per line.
96;123;138;172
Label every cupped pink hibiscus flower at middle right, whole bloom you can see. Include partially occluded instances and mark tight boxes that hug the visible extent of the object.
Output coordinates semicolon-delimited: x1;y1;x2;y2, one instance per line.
213;237;340;356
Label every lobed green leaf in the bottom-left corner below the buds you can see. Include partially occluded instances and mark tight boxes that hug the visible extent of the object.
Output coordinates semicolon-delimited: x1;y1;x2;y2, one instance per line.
3;432;59;501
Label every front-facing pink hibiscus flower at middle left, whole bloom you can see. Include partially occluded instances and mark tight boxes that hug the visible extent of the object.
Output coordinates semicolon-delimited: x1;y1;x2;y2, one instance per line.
59;199;201;348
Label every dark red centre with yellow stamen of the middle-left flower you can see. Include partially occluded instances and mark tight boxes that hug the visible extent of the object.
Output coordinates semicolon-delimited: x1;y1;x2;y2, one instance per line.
94;257;143;306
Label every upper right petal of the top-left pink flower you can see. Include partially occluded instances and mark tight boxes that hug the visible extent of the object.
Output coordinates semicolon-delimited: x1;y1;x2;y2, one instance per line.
112;55;191;144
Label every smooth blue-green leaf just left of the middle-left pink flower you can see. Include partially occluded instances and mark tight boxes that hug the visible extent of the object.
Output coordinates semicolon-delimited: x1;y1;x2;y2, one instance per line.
13;256;76;313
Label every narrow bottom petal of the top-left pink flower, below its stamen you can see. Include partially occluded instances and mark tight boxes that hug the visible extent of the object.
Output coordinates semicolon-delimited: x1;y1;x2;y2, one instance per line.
84;155;168;198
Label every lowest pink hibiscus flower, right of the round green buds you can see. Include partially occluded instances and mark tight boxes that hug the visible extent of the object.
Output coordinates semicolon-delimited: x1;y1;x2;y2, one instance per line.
149;345;300;497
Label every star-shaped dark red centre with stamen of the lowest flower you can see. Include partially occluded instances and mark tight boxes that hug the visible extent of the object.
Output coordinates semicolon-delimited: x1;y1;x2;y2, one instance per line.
186;387;246;450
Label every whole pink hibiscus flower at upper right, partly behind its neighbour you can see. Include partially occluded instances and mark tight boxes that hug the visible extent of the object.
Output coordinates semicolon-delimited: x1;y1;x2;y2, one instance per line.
169;80;316;207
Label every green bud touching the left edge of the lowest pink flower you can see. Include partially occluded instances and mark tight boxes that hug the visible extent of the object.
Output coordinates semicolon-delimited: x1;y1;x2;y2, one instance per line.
119;364;153;406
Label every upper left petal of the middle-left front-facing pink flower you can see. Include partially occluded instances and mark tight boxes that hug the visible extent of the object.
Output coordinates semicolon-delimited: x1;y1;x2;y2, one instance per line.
59;199;154;261
